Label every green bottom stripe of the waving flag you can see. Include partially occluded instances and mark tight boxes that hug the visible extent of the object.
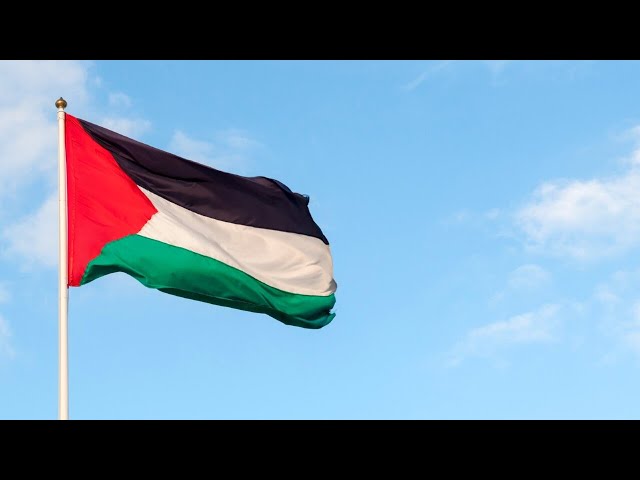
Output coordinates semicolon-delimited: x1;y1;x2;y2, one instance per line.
80;235;336;328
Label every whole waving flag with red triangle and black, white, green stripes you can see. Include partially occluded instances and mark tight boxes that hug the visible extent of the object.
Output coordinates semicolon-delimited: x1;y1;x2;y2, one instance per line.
65;114;336;328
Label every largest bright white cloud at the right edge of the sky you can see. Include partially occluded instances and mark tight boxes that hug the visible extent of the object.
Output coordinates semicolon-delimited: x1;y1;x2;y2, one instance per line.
515;145;640;260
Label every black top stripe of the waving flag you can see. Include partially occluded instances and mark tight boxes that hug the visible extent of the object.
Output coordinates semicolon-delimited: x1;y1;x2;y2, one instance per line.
78;119;329;245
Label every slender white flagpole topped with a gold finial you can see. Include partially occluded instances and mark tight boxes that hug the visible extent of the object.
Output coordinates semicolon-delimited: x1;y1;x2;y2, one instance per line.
56;97;69;420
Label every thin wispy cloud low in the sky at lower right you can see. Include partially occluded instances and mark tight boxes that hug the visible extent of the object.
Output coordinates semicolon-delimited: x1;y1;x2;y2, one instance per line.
449;305;560;366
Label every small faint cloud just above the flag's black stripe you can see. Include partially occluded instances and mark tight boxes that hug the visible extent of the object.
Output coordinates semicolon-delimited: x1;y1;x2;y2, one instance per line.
169;129;261;173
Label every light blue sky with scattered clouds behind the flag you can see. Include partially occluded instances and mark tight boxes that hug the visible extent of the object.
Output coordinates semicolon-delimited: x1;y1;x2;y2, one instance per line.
0;61;640;419
